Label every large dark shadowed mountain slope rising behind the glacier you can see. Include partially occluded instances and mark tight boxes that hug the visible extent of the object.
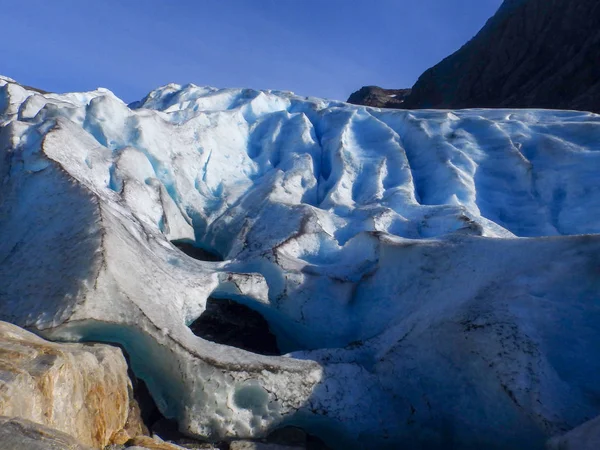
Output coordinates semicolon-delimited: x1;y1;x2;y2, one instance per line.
402;0;600;112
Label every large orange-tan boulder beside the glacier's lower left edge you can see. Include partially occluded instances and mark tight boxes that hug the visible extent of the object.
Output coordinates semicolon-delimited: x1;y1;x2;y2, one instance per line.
0;322;136;448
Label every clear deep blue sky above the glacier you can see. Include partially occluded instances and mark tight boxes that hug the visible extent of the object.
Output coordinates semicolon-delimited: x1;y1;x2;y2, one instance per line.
0;0;502;102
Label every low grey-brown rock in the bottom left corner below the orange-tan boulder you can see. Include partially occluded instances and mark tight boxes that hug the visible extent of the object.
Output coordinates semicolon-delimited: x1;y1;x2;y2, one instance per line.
0;416;92;450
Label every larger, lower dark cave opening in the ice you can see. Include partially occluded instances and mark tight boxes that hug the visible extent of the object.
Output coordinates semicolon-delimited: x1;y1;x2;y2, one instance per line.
189;297;281;356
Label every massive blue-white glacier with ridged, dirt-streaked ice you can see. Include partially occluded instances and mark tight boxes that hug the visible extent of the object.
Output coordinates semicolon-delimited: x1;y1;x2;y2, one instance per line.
0;77;600;449
